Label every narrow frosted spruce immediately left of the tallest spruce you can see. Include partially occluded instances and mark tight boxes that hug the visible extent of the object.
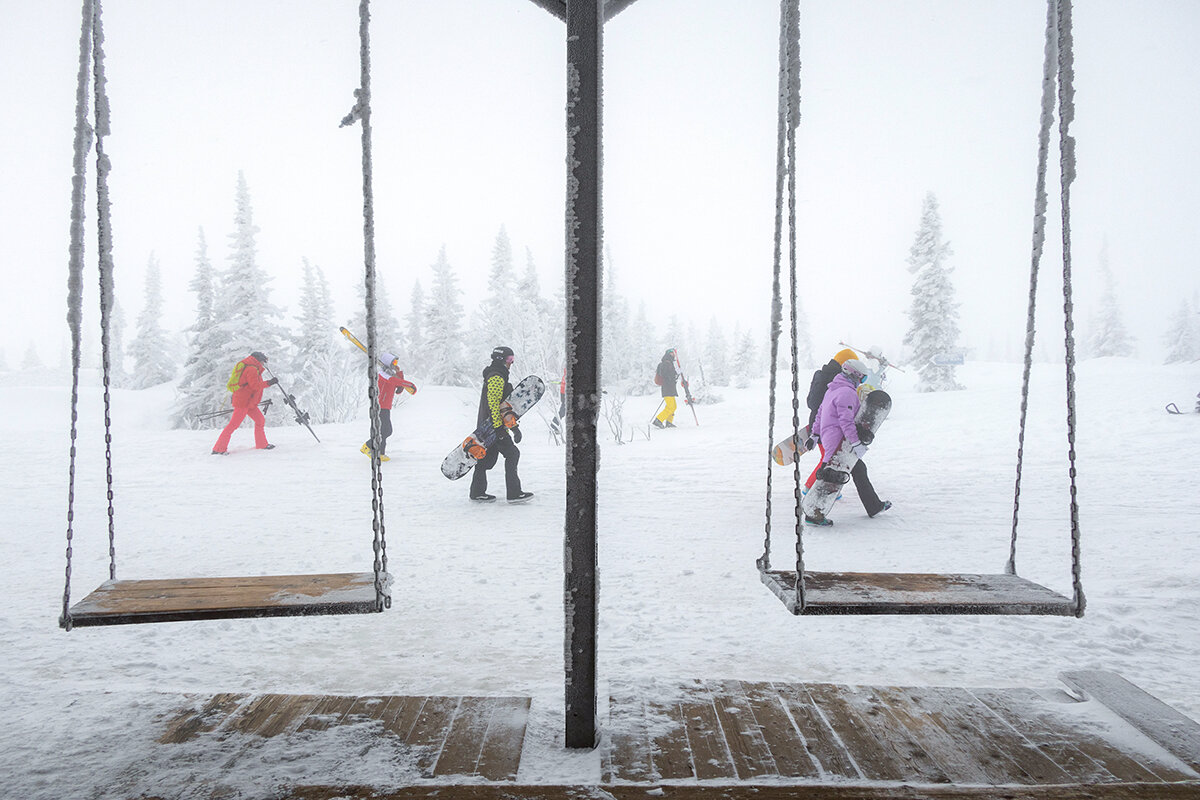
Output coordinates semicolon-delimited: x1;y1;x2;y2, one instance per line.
172;228;233;429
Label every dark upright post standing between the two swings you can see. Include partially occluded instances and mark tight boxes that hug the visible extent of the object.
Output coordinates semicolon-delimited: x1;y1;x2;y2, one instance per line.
563;0;604;748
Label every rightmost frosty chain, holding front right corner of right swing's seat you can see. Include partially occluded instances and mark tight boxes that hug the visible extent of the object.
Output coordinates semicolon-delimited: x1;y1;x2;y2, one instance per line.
1058;0;1086;616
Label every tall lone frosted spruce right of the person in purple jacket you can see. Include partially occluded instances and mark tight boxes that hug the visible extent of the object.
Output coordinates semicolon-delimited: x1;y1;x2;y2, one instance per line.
904;192;962;392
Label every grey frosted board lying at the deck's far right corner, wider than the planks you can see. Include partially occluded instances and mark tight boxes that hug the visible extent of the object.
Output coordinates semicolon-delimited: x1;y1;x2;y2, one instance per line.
1058;669;1200;772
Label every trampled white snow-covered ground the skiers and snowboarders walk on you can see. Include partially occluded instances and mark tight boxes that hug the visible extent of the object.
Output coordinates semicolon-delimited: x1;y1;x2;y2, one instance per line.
0;359;1200;799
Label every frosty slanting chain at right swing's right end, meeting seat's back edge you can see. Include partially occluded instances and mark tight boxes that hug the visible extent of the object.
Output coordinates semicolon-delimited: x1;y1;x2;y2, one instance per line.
1004;0;1058;575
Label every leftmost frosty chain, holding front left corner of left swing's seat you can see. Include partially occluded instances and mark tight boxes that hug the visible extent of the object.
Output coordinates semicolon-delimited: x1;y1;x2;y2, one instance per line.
59;0;94;631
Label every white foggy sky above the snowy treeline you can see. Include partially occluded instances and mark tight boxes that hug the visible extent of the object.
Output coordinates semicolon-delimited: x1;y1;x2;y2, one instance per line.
0;0;1200;368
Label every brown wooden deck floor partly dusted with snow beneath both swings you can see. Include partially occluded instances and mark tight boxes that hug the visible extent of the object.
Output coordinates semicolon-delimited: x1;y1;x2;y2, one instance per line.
131;670;1200;800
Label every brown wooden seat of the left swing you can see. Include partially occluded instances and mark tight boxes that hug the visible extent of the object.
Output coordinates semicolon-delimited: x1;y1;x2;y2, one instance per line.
63;572;386;627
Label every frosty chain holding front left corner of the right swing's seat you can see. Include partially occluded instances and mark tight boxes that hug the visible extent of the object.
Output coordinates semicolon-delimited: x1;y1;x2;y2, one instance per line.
780;0;805;610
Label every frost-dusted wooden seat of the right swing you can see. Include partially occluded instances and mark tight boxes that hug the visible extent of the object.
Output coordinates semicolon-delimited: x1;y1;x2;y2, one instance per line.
760;570;1075;616
